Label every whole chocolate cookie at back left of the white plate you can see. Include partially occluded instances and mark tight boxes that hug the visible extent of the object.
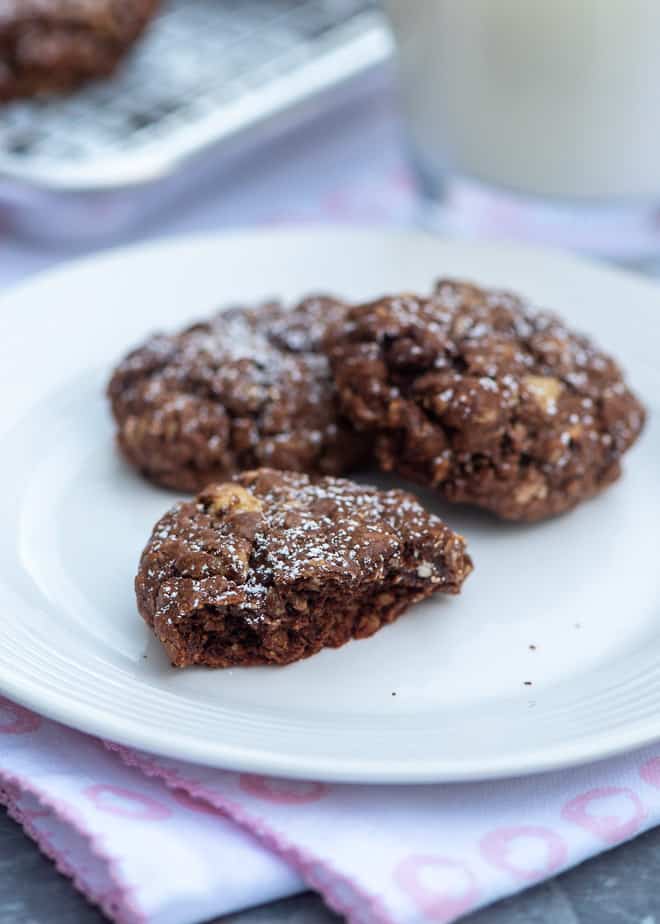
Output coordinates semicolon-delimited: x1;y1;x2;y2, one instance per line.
109;297;369;491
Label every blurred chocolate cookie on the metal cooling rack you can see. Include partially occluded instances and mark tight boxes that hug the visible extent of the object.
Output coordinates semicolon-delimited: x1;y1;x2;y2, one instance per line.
0;0;159;101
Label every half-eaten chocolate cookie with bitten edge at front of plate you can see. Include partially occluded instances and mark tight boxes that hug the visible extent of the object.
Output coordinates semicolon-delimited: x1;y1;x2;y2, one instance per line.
135;469;472;667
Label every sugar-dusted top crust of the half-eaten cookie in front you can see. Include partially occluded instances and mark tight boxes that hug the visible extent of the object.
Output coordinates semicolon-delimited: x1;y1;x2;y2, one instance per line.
138;469;469;648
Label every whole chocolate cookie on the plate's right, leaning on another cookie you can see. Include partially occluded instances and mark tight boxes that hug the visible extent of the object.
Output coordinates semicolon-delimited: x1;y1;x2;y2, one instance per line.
326;281;644;521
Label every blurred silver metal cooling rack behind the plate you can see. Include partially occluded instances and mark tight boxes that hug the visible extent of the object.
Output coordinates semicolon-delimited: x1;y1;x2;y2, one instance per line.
0;0;391;238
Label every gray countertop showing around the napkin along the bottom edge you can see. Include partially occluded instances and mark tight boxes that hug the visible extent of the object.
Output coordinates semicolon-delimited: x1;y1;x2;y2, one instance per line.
0;813;660;924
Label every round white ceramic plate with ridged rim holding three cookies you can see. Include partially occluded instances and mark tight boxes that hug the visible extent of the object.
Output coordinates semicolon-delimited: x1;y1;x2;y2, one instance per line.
0;229;660;782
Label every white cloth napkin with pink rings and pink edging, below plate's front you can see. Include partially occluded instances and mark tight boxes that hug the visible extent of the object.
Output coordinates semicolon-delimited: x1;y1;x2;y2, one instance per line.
0;699;660;924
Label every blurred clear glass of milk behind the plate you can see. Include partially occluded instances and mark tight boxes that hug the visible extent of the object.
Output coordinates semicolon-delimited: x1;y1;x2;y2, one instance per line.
383;0;660;258
